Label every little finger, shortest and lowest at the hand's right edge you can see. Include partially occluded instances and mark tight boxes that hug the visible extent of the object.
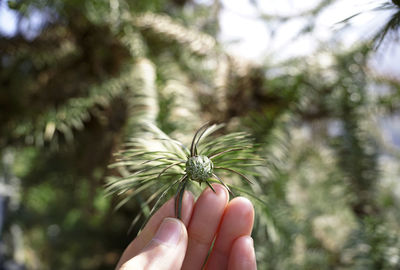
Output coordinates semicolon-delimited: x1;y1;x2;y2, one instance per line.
228;236;257;270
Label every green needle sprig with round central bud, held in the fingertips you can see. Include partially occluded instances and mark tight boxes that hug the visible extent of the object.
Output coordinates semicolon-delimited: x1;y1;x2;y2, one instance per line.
107;124;262;227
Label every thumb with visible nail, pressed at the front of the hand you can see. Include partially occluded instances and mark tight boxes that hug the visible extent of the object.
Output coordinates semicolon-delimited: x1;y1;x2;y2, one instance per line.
121;218;188;270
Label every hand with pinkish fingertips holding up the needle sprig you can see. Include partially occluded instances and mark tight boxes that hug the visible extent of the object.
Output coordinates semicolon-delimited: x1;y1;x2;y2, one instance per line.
116;184;257;270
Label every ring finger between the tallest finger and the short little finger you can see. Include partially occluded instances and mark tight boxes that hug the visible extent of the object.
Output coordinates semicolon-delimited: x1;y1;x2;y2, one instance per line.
207;197;254;270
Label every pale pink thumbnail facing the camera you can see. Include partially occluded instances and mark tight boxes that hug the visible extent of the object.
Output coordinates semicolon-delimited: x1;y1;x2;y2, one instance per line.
154;218;182;246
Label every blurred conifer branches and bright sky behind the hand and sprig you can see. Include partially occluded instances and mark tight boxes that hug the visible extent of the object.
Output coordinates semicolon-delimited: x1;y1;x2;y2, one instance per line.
0;0;400;270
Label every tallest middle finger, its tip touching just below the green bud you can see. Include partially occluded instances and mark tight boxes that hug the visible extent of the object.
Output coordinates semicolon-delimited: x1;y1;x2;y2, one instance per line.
182;184;229;270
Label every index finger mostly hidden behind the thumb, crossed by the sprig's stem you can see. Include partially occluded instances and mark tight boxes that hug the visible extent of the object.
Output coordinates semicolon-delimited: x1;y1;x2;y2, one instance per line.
116;191;194;269
